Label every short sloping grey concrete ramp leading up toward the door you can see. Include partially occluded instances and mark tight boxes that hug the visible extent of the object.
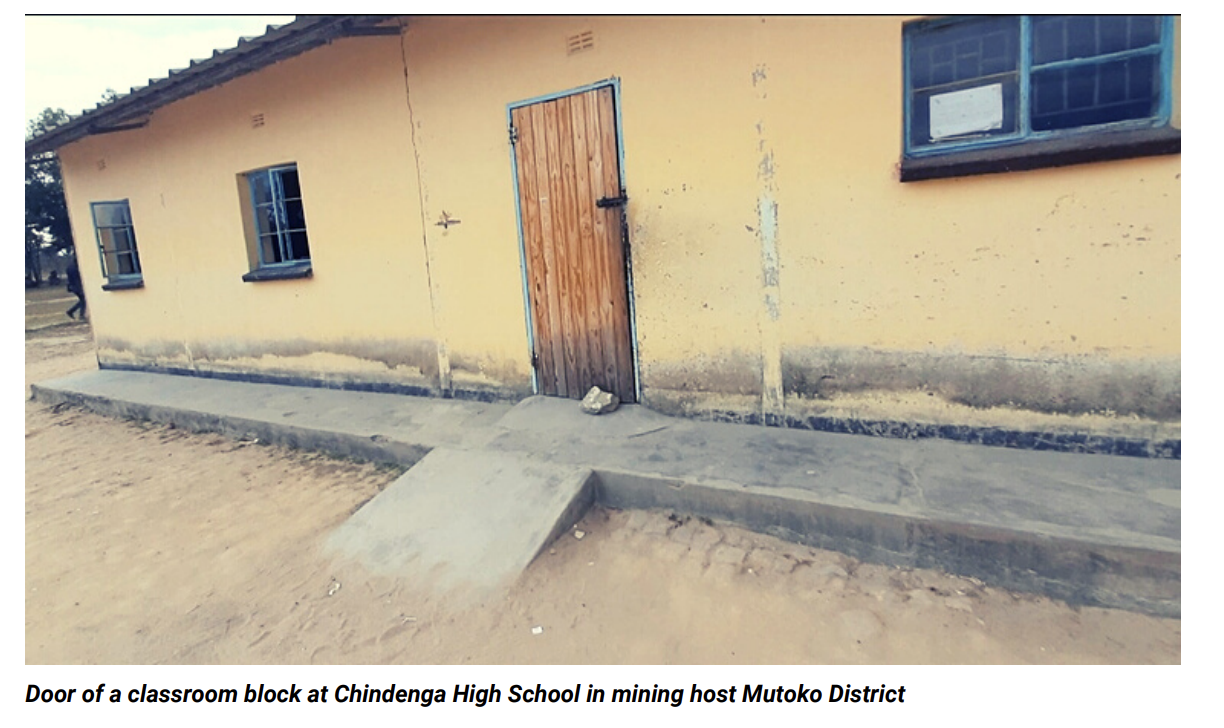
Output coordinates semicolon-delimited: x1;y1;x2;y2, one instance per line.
326;448;595;593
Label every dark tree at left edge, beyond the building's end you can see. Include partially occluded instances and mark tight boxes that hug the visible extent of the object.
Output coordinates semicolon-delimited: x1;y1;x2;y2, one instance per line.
26;109;72;288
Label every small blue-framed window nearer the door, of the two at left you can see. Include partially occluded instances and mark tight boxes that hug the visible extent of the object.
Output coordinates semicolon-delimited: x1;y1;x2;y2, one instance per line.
244;164;311;280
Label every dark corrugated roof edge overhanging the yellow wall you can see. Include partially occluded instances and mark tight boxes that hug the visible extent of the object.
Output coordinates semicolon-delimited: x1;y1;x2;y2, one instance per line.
26;15;399;157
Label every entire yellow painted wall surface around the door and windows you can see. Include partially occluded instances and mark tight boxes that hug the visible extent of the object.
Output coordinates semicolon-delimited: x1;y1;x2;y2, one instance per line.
62;17;1180;428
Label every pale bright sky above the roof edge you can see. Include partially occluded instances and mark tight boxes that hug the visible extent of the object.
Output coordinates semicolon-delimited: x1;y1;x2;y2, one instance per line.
26;15;293;124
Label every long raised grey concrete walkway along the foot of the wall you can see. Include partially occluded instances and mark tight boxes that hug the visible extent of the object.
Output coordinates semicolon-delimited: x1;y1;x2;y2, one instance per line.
26;370;1181;615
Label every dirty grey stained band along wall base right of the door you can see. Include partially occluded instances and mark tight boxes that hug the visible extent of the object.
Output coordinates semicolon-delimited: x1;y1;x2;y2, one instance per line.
643;347;1181;459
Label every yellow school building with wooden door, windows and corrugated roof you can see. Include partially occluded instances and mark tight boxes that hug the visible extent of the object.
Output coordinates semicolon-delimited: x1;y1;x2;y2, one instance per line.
26;16;1181;450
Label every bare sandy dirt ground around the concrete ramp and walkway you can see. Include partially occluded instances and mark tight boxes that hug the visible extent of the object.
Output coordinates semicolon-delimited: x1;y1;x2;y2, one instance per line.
26;324;1181;664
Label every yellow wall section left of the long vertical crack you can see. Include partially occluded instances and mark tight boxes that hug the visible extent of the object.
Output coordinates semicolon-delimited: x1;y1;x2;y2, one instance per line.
60;30;460;388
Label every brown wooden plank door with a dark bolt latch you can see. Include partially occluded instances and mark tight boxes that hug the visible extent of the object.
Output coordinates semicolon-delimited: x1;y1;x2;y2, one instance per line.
510;87;636;403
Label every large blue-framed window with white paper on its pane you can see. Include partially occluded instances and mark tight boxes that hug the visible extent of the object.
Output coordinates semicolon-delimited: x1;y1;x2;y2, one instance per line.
905;15;1173;158
